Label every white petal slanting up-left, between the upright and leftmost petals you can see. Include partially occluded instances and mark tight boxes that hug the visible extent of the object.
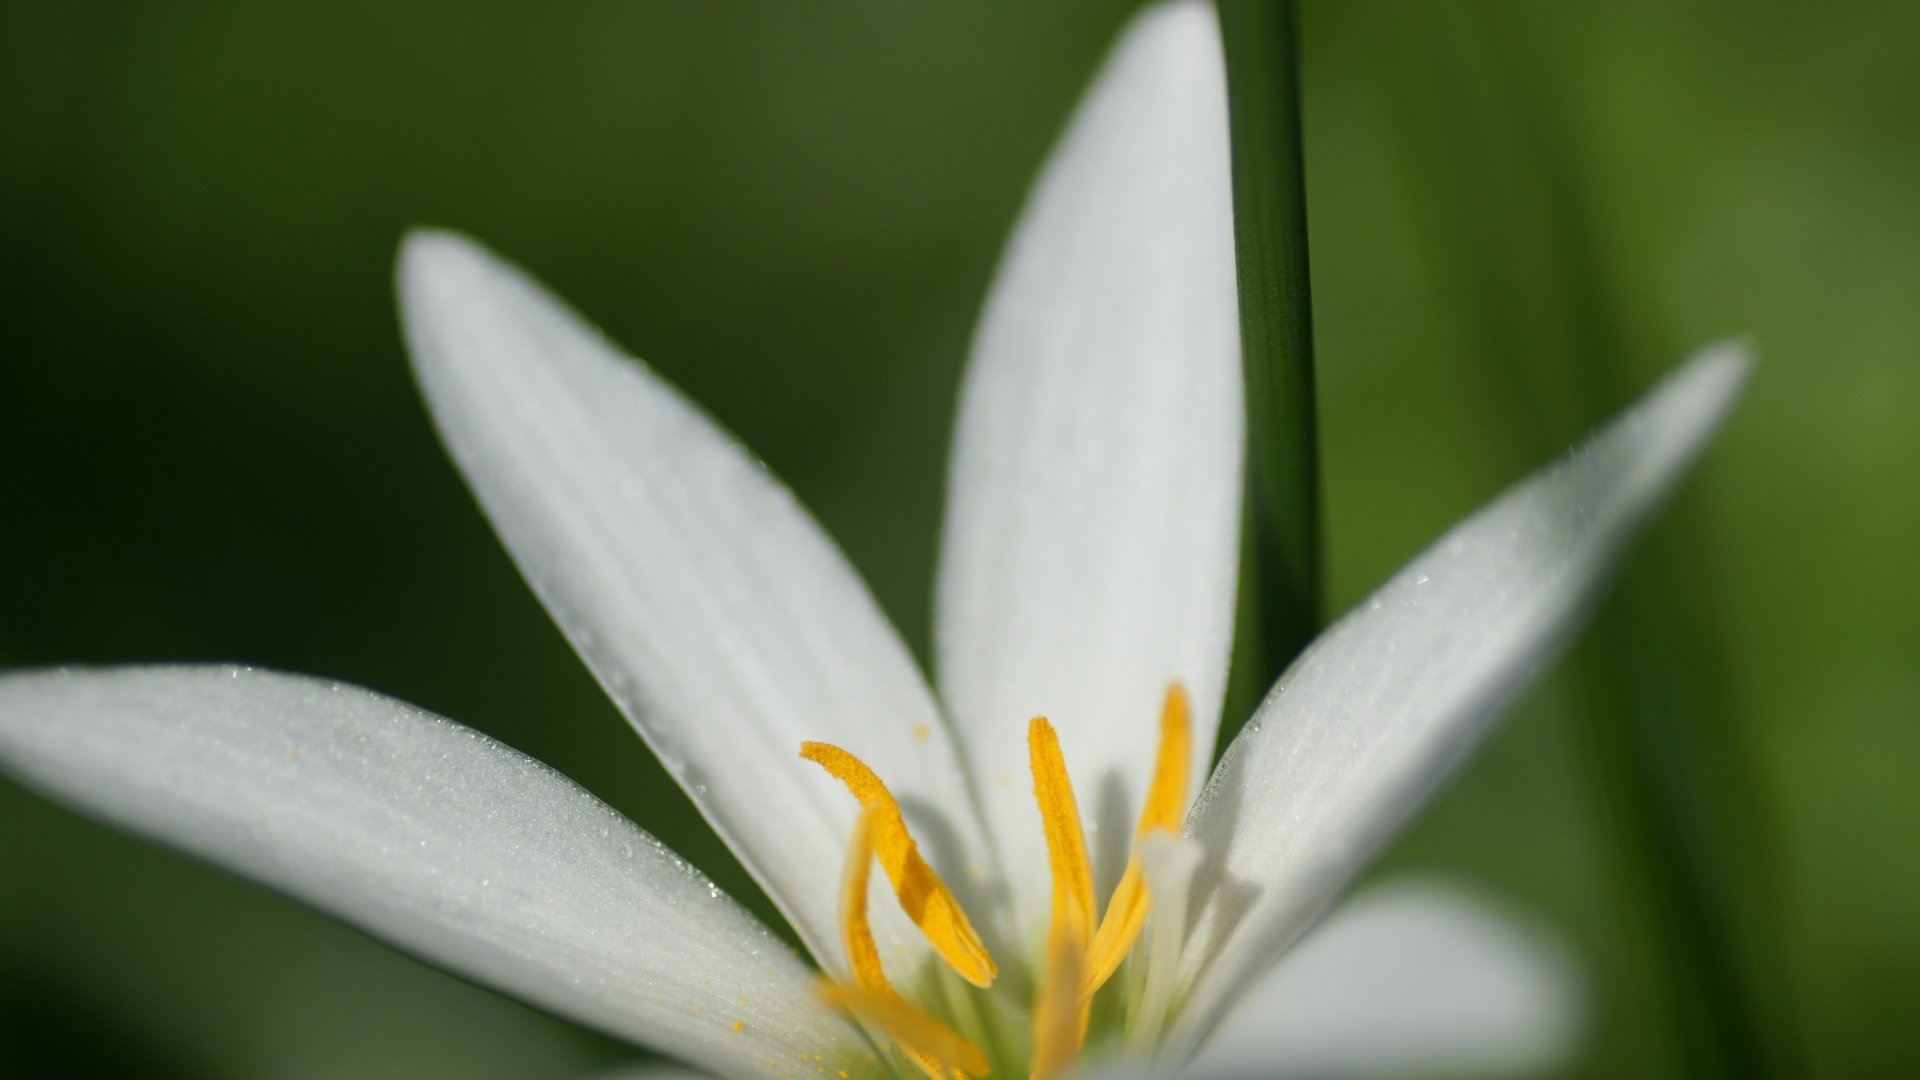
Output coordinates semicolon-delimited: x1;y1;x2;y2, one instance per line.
399;233;987;965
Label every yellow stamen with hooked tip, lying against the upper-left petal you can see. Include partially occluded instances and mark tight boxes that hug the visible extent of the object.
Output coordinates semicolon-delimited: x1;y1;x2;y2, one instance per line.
801;742;998;988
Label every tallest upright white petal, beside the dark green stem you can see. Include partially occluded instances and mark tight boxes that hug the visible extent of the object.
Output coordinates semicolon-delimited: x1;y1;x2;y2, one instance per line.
937;2;1244;917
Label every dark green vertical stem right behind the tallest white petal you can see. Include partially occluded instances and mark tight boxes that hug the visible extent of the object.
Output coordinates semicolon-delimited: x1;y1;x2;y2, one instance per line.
1219;0;1321;726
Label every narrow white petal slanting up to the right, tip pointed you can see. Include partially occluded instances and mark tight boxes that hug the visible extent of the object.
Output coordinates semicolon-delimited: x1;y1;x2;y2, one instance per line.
1179;346;1747;1036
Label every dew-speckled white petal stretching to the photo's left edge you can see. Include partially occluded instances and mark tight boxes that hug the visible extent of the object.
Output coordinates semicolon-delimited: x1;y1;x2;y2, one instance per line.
0;667;866;1076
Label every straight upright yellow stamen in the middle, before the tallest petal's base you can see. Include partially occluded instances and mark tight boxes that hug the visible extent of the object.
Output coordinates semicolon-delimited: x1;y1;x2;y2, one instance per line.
1027;717;1092;1076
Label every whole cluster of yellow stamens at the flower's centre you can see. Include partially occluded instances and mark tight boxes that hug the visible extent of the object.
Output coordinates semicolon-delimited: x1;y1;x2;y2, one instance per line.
801;682;1192;1080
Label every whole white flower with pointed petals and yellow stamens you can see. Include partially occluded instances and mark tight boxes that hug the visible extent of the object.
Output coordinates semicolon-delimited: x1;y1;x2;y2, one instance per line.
0;2;1745;1076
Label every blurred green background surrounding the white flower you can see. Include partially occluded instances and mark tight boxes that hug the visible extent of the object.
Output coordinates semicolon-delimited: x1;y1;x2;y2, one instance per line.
0;0;1920;1080
